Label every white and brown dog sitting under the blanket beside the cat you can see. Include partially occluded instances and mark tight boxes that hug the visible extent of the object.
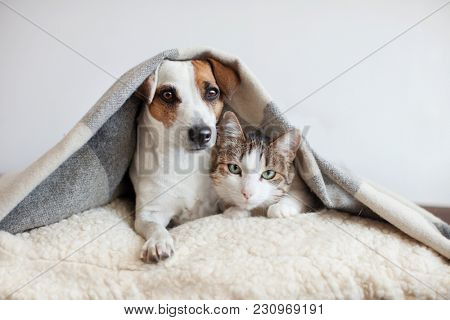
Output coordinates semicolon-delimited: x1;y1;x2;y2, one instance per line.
130;59;240;262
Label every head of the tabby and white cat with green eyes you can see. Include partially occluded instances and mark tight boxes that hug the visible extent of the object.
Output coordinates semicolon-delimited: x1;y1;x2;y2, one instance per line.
211;111;300;210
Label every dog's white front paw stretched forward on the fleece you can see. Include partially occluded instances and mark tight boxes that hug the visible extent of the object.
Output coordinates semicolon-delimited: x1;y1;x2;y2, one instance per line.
141;230;174;263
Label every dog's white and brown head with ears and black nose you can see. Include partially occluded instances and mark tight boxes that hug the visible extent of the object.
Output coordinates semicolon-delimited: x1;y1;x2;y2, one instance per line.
137;59;239;151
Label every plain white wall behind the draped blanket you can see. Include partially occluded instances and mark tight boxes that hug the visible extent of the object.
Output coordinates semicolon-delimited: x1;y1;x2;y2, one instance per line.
0;0;450;205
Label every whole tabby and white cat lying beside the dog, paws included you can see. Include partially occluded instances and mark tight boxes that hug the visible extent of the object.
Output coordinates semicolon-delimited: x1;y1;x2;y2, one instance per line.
210;111;314;218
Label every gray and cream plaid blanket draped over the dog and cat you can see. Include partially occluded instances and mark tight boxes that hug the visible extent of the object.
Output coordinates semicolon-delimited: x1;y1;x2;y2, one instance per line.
0;48;450;258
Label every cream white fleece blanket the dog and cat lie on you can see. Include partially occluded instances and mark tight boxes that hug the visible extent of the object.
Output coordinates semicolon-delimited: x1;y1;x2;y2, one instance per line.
0;199;450;299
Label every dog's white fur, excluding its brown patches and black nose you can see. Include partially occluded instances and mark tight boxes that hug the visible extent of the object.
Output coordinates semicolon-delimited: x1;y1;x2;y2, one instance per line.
130;61;225;262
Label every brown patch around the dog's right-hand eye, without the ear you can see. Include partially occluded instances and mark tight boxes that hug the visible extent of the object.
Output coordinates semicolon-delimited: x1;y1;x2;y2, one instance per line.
191;60;223;120
